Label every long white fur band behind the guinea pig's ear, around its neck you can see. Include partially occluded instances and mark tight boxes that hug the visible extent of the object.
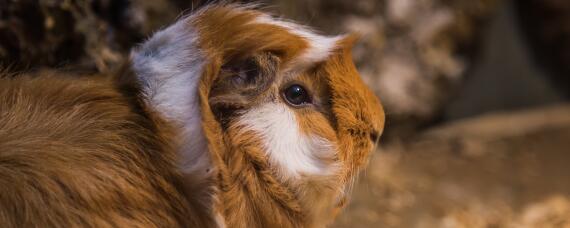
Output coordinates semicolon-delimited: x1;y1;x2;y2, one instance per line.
131;18;211;178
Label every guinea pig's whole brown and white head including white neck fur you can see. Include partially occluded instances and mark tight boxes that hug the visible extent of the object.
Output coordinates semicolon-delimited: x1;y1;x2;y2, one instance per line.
132;5;384;227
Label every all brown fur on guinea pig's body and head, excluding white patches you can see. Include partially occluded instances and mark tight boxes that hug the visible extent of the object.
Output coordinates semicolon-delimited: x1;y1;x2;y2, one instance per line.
0;5;384;227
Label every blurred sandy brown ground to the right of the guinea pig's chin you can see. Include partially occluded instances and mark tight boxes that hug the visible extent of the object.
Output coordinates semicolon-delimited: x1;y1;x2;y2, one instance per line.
334;105;570;228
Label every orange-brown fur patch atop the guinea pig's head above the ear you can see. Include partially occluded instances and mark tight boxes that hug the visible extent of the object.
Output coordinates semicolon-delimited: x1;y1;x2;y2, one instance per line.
189;6;308;67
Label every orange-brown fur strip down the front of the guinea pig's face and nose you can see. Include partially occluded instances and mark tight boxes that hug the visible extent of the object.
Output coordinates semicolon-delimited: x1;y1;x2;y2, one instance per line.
321;36;384;182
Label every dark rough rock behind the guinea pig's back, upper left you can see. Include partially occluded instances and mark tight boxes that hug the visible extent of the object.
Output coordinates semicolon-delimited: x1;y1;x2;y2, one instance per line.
0;0;192;72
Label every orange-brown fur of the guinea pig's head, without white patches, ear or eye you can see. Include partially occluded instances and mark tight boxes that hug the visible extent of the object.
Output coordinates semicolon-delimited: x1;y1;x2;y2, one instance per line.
196;7;384;227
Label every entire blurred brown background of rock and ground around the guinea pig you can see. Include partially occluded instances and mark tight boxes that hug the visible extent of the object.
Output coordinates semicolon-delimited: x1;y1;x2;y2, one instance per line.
0;0;570;227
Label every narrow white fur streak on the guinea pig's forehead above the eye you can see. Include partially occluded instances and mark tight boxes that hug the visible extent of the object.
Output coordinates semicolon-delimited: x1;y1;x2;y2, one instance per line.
255;14;343;64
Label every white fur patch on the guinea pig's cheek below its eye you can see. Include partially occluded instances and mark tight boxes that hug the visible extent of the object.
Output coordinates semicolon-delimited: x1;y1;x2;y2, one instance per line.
234;103;338;179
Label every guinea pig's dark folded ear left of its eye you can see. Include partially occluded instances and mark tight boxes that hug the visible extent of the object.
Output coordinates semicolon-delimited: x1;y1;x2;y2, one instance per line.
208;52;279;122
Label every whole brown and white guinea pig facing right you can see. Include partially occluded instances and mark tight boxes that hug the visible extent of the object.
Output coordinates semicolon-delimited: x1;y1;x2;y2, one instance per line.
0;4;384;227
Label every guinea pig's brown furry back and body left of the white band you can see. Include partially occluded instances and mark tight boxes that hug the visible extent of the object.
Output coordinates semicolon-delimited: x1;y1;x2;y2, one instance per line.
0;76;209;227
